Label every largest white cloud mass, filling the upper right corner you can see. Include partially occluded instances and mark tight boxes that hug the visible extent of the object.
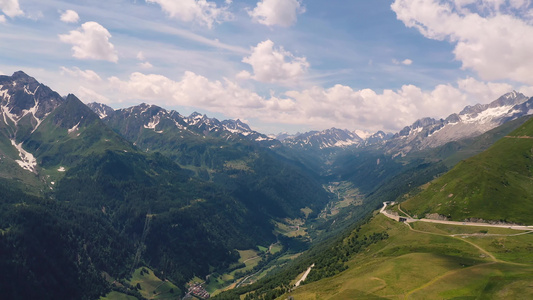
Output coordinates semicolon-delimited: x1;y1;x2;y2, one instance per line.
391;0;533;85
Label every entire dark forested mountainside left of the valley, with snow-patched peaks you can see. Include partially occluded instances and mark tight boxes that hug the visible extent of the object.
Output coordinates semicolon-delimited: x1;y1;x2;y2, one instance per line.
0;72;329;299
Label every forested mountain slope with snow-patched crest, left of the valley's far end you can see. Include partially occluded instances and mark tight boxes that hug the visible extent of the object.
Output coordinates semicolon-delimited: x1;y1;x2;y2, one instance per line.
90;104;328;217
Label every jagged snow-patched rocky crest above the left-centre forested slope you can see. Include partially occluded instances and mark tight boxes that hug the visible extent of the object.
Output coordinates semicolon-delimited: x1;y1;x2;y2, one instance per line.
88;103;279;146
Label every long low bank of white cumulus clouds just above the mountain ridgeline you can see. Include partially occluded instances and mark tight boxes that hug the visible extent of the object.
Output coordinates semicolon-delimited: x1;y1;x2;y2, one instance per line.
108;72;526;132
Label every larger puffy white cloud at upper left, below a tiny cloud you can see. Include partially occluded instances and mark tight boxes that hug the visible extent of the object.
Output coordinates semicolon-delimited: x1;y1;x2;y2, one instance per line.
59;22;118;62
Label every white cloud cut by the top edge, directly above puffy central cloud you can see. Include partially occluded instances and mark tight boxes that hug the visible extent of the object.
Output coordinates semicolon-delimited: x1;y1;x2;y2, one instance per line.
248;0;305;27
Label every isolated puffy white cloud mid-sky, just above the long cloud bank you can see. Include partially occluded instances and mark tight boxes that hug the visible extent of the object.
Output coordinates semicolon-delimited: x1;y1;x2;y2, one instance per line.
241;40;309;84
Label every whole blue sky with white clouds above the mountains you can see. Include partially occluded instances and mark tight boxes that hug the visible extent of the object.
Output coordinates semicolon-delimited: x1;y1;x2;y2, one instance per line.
0;0;533;133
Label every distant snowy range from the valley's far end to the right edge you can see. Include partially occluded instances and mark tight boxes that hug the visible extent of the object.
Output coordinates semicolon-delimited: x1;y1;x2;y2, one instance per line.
278;91;533;156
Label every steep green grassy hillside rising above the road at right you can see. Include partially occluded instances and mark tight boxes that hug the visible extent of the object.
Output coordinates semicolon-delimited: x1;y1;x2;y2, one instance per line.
402;116;533;224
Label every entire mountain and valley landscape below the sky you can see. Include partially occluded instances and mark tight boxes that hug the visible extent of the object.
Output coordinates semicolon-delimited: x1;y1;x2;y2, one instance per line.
0;71;533;300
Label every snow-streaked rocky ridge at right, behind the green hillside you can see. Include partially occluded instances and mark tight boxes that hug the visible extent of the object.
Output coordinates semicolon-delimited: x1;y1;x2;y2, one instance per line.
384;91;533;156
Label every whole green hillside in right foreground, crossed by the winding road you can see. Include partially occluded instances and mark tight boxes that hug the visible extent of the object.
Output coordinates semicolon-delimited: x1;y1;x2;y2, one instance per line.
215;94;533;299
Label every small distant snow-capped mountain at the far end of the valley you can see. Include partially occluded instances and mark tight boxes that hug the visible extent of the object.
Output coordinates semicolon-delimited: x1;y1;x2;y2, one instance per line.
283;128;363;149
